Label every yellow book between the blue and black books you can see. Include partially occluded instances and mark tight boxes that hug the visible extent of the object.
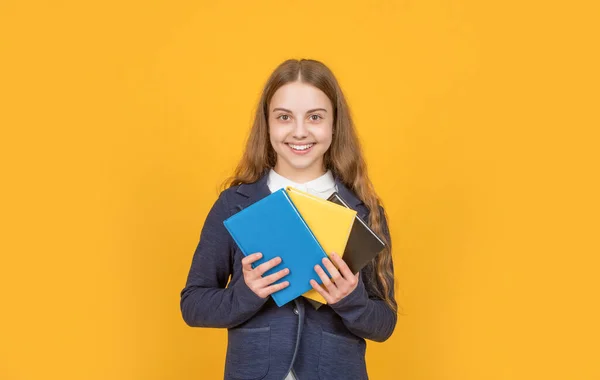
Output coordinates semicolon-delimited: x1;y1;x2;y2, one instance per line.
285;186;356;304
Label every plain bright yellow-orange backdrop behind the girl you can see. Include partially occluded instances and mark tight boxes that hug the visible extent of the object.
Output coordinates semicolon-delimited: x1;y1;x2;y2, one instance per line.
0;0;600;380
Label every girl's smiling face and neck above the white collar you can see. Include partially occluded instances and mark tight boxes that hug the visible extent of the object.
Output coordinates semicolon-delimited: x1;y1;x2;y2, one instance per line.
269;82;333;183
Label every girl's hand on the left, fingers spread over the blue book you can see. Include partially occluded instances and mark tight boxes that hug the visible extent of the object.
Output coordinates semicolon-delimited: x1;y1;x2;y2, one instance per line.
242;252;290;298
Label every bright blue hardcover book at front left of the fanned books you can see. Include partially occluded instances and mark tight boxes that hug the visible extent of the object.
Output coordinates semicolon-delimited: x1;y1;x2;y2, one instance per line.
223;189;331;307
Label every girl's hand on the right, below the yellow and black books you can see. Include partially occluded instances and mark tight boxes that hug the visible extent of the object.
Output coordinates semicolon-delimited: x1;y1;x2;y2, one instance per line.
310;253;360;305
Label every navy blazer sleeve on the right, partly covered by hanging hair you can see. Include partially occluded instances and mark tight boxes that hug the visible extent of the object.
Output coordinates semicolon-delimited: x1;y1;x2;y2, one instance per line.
329;207;397;342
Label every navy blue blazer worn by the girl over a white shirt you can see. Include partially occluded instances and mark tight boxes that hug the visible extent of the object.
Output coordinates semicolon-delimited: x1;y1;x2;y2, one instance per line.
181;173;396;380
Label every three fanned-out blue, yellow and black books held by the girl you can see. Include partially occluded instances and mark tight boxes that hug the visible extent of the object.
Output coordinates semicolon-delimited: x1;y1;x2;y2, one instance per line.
223;187;385;308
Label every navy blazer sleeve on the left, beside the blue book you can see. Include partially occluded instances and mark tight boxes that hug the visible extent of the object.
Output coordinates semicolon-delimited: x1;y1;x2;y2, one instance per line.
180;191;268;328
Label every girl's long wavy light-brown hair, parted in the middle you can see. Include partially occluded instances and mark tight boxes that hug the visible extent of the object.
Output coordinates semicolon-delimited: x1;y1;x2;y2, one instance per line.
221;59;397;312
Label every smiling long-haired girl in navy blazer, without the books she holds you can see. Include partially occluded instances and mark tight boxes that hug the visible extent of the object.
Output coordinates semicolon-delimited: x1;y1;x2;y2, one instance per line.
181;59;397;380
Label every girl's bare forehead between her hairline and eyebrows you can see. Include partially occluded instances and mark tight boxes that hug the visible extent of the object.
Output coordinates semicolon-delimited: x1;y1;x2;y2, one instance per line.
269;82;332;112
